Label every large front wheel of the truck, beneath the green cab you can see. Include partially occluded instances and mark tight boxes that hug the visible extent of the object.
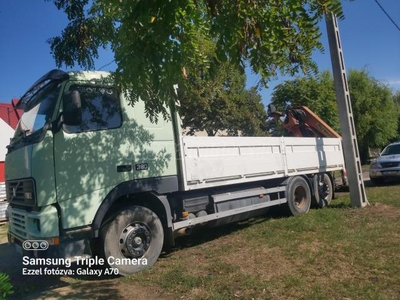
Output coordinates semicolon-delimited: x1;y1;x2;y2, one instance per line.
100;206;164;275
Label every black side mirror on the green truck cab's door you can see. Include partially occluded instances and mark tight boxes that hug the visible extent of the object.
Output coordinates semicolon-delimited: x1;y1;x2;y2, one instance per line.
63;90;82;126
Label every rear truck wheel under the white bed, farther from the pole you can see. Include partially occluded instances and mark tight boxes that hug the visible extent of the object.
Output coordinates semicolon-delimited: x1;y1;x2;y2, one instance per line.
286;177;311;216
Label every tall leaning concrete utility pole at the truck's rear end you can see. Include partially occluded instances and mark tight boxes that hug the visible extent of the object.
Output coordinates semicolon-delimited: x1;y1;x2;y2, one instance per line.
325;14;368;207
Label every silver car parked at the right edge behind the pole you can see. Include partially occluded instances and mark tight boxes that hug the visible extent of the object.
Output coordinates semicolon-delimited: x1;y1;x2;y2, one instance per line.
369;142;400;185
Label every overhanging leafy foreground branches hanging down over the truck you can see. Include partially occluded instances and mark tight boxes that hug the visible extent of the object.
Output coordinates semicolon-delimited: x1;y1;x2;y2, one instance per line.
47;0;342;116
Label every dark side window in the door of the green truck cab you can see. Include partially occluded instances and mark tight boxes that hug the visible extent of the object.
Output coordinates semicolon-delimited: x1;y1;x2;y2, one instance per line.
64;85;122;133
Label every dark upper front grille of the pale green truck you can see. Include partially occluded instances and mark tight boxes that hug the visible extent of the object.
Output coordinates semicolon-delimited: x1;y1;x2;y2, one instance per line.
6;178;36;206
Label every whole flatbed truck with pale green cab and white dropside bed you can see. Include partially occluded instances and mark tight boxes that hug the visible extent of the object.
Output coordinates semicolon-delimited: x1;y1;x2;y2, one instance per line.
6;70;344;275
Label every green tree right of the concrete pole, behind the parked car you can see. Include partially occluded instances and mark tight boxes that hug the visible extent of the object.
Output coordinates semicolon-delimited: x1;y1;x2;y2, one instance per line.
348;70;398;163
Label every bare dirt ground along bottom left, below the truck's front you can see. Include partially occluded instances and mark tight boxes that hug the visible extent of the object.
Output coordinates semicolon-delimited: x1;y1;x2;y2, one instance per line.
0;226;174;300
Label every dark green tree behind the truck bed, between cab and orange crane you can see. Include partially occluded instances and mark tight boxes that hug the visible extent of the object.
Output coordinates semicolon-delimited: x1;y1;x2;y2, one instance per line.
179;35;267;136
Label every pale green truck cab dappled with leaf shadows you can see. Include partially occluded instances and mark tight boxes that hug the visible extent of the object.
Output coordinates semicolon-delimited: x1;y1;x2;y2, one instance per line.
6;70;178;274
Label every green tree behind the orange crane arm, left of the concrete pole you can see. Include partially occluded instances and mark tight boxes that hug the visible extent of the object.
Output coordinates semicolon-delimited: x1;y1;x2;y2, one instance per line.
271;71;340;132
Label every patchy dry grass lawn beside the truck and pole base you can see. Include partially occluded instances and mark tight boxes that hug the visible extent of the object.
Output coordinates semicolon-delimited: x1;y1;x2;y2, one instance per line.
127;185;400;299
